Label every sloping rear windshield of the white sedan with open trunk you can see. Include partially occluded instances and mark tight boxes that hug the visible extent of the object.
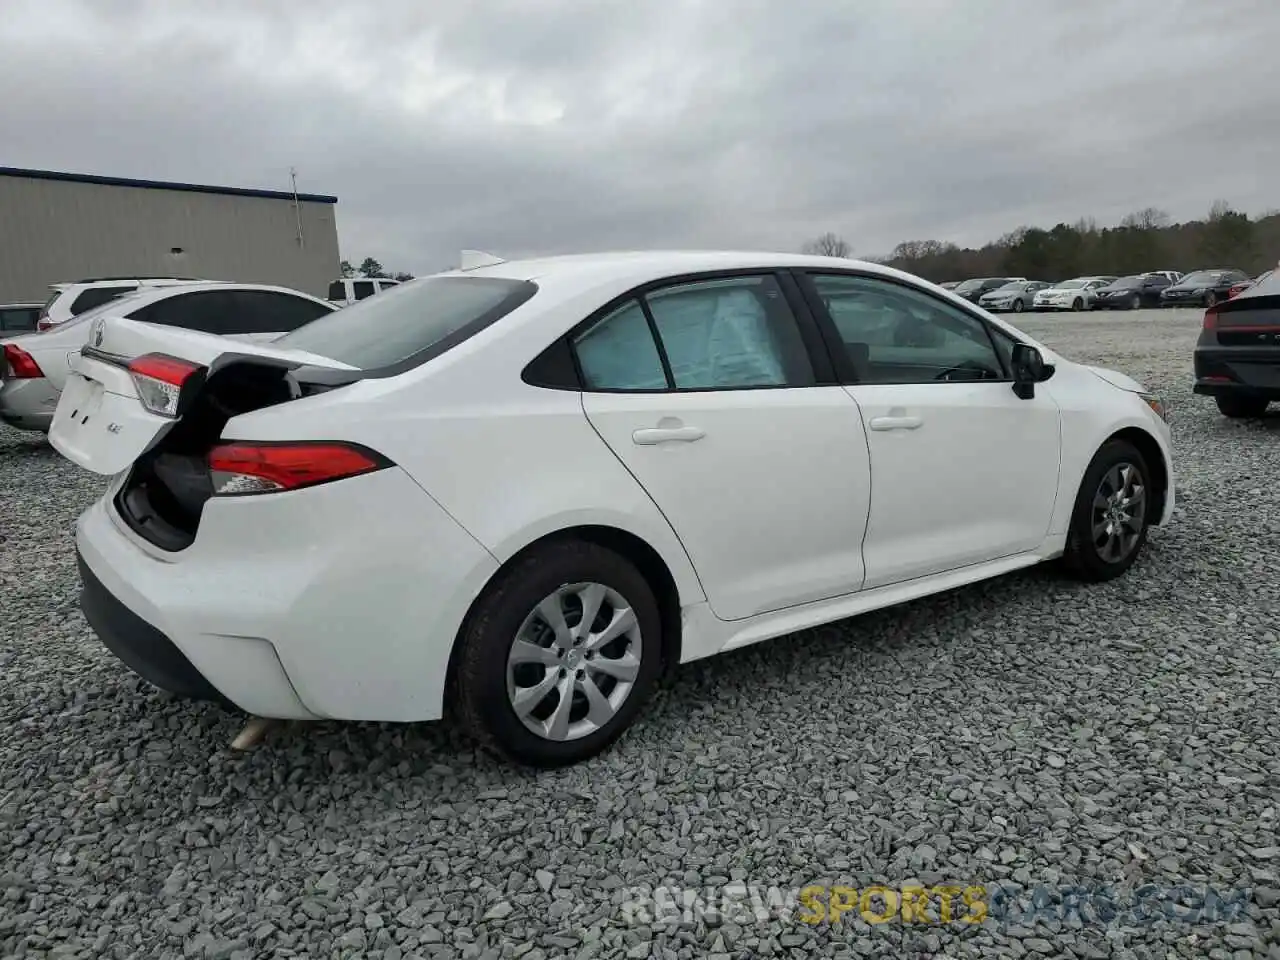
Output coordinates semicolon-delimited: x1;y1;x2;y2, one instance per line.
276;276;538;370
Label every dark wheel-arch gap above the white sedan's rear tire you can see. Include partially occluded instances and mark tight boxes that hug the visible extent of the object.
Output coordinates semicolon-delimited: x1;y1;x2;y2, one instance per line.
444;524;684;708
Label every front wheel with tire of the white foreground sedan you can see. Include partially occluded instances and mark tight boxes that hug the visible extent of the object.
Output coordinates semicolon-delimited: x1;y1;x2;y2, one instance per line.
1062;440;1152;582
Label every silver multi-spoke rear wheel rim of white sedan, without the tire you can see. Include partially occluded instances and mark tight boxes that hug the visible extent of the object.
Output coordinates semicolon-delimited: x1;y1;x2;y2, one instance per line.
507;582;643;741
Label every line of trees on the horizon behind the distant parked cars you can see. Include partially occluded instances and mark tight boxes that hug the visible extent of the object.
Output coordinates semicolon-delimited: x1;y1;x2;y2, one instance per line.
804;200;1280;283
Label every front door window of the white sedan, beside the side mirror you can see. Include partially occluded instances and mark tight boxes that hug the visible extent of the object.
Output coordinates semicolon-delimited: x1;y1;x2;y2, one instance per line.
813;275;1011;383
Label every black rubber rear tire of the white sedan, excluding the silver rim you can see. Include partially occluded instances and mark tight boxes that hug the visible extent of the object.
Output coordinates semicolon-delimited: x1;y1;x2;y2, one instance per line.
451;540;663;768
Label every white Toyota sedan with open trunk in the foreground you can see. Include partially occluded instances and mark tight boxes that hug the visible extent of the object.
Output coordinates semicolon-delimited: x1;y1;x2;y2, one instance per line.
51;252;1174;765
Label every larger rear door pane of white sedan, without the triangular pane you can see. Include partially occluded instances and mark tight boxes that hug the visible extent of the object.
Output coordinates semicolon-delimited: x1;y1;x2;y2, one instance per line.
645;276;814;390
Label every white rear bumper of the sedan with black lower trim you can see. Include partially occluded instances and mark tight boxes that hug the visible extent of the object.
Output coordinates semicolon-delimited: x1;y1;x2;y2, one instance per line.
76;467;498;721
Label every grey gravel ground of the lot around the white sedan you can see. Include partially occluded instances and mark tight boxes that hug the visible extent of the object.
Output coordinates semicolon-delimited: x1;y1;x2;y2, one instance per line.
0;311;1280;960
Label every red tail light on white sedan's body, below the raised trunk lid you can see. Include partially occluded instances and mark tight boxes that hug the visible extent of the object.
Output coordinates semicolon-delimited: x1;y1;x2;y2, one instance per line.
209;440;390;497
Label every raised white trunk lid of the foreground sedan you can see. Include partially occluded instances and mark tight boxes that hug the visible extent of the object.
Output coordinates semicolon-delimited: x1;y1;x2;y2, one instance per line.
49;320;353;476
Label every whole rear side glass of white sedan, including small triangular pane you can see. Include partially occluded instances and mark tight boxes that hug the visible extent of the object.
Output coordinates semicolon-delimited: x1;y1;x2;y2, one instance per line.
573;275;815;390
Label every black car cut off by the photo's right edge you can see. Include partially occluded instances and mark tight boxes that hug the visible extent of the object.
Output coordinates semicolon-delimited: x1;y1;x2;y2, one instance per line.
1192;270;1280;417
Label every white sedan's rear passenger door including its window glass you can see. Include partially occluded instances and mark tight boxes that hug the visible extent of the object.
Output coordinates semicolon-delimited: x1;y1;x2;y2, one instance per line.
573;273;870;621
